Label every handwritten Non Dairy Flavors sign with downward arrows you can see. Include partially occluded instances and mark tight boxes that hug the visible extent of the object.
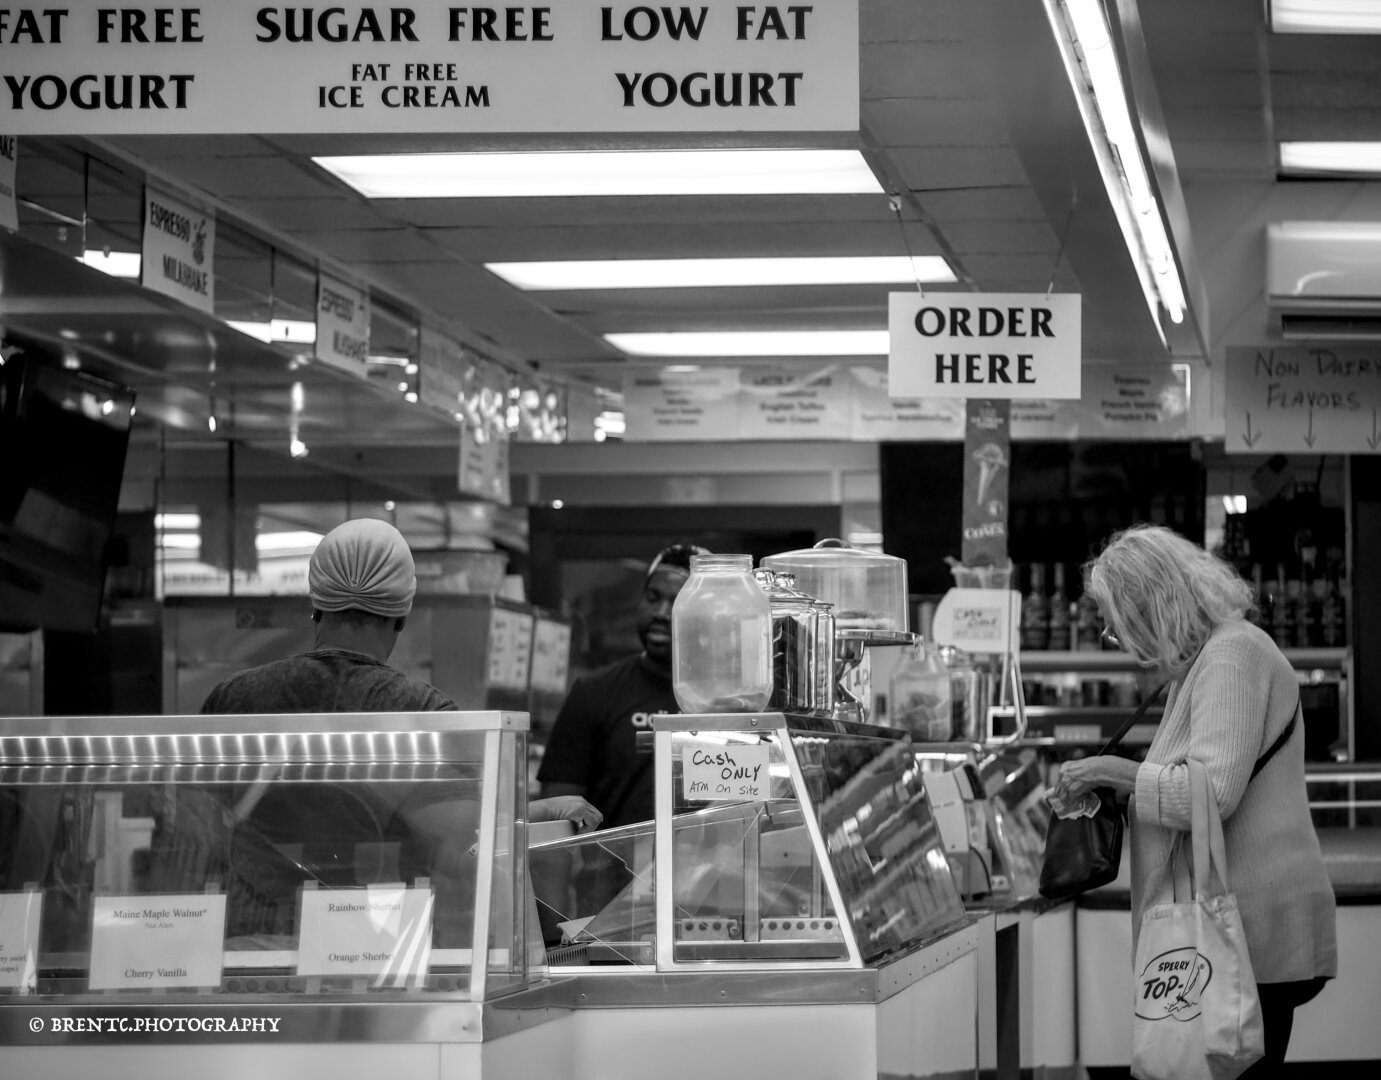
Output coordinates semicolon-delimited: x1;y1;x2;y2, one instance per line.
1224;345;1381;454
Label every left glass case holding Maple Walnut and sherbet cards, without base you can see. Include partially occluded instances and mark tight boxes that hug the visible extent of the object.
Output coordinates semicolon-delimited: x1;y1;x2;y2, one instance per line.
0;711;544;1004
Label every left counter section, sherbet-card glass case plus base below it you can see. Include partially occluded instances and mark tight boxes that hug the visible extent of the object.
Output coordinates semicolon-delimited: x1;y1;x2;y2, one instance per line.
0;713;566;1079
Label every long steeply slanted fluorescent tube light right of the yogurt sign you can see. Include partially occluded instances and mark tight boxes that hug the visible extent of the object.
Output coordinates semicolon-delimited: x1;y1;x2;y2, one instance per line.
1045;0;1186;341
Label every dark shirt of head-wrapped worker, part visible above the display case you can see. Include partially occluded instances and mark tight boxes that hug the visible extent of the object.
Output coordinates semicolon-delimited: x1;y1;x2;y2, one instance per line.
202;649;456;714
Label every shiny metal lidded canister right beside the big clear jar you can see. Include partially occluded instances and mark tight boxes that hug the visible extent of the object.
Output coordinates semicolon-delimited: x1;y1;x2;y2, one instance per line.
753;569;834;713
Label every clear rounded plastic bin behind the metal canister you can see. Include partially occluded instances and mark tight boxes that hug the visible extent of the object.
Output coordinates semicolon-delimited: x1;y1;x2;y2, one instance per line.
762;540;910;631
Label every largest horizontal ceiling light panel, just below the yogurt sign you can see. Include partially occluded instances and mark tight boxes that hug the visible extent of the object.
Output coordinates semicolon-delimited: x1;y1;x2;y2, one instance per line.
312;149;882;199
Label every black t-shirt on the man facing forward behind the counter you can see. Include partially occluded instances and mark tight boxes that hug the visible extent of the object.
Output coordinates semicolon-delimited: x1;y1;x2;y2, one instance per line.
537;653;681;829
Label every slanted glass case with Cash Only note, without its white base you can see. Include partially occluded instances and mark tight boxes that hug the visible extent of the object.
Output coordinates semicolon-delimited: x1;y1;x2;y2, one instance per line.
530;713;967;971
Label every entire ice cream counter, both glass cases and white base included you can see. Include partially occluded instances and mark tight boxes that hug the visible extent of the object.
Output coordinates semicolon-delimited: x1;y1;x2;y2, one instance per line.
0;713;993;1080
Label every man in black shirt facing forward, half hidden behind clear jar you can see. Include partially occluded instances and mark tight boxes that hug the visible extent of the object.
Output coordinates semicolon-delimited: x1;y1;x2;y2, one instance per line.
537;544;710;829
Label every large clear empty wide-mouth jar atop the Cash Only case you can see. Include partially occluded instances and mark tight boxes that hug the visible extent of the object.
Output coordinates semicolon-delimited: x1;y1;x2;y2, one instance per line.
671;555;772;713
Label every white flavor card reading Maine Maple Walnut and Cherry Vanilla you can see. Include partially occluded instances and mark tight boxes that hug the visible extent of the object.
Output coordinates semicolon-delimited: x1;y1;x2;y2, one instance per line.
90;892;225;990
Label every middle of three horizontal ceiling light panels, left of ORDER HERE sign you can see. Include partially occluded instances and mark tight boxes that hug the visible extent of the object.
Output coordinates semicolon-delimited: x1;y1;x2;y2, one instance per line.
485;255;956;290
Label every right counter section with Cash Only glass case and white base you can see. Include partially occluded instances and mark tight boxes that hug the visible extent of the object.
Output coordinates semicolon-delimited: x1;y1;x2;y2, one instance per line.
530;713;992;1080
